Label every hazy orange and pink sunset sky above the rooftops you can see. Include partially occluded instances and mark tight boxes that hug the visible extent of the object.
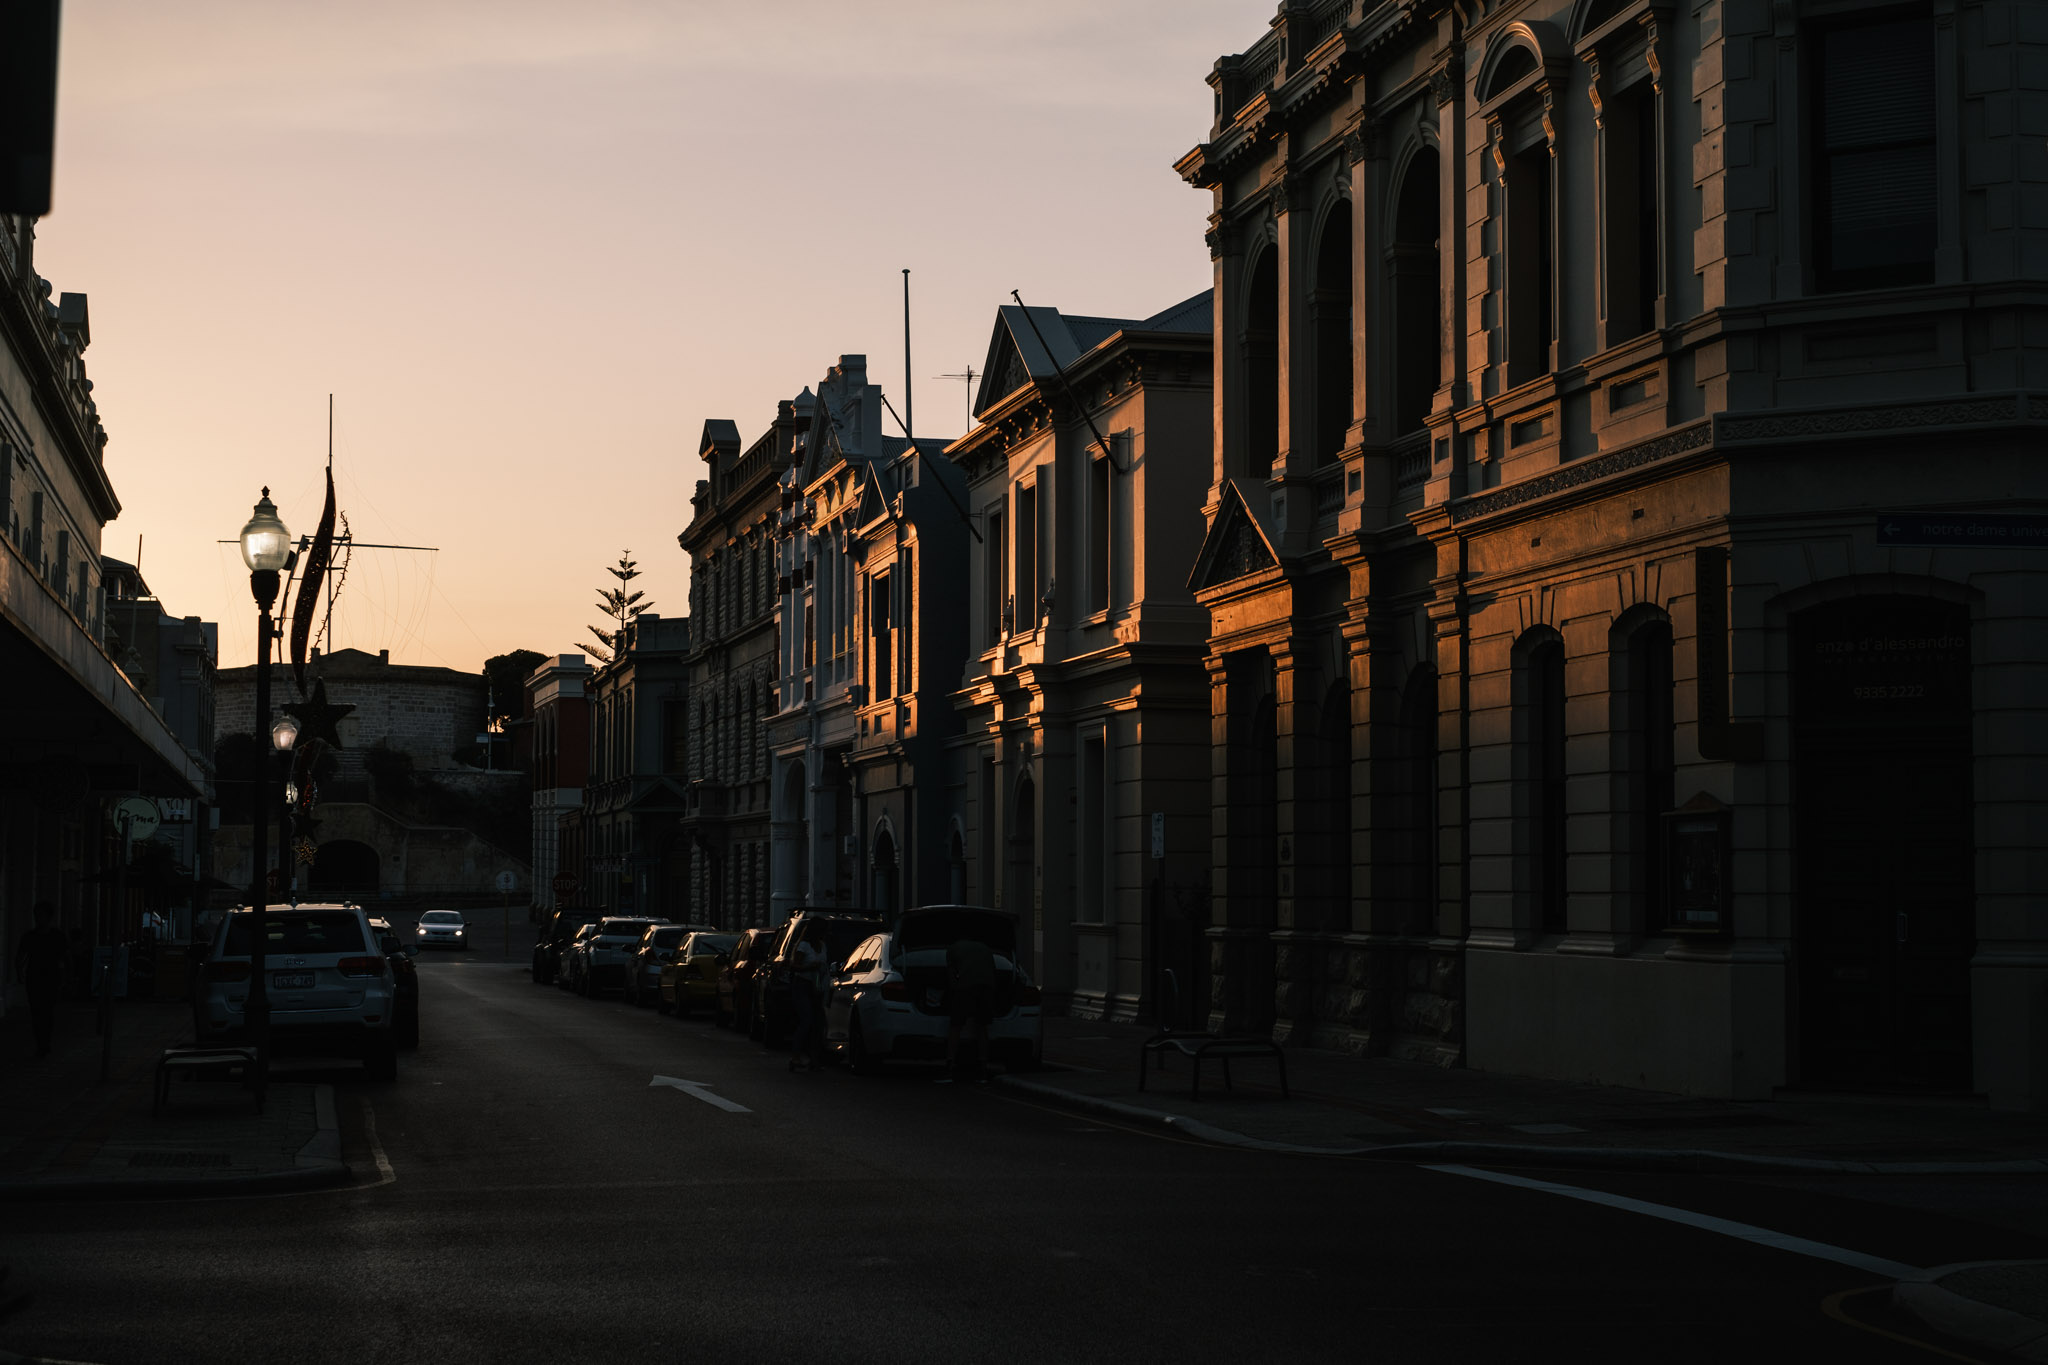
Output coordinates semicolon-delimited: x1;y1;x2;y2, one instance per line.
35;0;1245;671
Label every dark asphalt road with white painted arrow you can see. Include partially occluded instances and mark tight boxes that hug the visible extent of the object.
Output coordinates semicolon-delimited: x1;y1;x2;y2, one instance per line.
0;935;2048;1365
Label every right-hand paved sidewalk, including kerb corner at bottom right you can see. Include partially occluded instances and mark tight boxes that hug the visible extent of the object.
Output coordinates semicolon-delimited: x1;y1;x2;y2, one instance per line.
995;1019;2048;1361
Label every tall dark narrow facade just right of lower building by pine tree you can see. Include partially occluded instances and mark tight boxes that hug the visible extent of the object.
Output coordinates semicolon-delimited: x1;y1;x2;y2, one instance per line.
676;403;799;929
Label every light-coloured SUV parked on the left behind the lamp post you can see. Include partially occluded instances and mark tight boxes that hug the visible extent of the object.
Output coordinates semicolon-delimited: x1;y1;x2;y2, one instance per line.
193;905;397;1081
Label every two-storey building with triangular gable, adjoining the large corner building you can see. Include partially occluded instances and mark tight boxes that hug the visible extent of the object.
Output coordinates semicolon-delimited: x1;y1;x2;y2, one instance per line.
942;293;1212;1019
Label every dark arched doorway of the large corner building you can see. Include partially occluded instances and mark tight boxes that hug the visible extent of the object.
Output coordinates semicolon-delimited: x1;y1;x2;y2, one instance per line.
1792;598;1976;1091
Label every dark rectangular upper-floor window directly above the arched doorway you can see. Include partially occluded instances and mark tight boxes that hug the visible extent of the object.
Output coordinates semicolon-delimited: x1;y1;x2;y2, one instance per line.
1812;18;1935;291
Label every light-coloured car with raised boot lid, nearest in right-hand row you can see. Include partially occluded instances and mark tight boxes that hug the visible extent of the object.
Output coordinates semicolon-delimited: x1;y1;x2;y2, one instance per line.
825;905;1044;1072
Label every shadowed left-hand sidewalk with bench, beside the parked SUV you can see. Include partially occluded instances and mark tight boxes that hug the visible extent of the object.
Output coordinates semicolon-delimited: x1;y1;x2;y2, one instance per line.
0;1001;348;1201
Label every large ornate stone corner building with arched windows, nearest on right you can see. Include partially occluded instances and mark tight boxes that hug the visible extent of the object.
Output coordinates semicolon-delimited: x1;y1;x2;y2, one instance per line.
1180;0;2048;1109
